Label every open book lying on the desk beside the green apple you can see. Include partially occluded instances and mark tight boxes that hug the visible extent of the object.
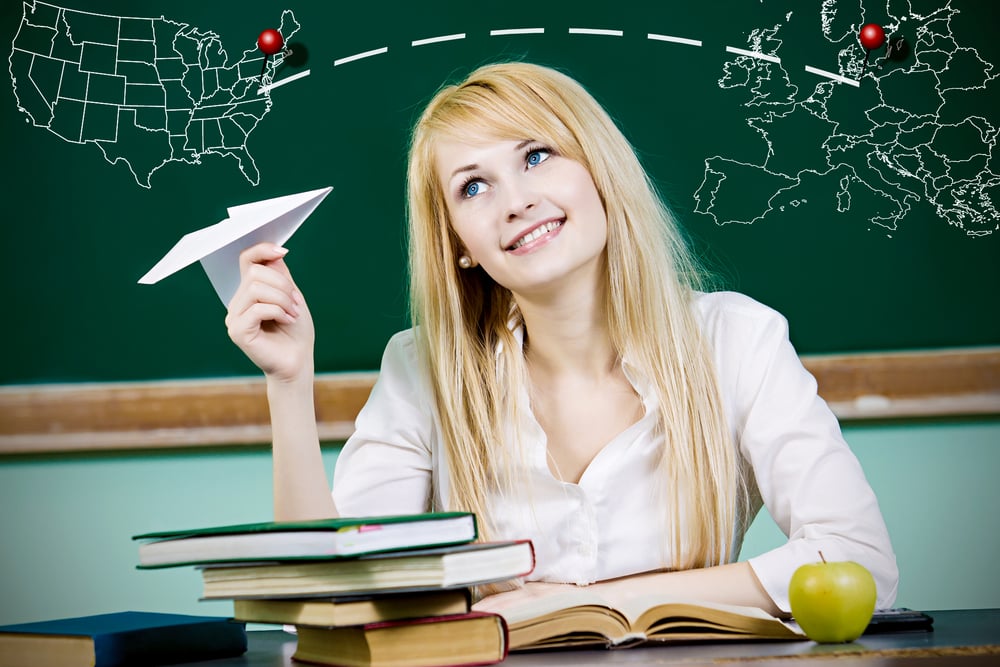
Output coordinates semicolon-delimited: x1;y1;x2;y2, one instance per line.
491;588;805;651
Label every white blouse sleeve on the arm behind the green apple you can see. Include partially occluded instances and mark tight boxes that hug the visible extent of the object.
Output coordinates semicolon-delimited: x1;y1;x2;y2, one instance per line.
710;294;898;611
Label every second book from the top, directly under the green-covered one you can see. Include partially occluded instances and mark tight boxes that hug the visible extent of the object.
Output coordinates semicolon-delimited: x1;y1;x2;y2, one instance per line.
201;540;535;600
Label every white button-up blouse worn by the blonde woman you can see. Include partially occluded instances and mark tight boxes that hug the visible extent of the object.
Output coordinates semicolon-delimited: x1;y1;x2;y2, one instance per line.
333;292;898;611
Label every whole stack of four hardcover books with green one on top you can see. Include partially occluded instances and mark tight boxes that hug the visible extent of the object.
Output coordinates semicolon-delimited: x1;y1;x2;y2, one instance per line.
134;512;535;667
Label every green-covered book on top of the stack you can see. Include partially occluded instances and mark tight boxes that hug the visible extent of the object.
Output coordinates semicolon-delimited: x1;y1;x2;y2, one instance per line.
132;512;479;568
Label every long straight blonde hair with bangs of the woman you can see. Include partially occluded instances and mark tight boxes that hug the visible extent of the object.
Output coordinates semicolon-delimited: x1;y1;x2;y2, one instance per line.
407;62;746;568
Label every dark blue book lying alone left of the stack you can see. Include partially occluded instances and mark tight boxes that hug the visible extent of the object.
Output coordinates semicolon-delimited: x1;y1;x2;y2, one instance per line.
0;611;247;667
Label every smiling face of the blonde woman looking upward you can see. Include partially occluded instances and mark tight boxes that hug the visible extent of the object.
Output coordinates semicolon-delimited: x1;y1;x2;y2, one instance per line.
436;139;608;295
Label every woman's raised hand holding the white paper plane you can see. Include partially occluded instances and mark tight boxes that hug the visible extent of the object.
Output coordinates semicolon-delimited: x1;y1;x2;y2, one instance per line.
226;243;315;382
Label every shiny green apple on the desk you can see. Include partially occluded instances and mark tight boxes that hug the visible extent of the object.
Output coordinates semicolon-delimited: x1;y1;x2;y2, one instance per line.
788;552;875;644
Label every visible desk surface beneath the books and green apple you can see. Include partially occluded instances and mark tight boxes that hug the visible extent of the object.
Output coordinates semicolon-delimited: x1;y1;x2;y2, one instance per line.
188;609;1000;667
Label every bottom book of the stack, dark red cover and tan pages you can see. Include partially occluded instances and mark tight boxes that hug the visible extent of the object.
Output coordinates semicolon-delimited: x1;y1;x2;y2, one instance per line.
292;612;508;667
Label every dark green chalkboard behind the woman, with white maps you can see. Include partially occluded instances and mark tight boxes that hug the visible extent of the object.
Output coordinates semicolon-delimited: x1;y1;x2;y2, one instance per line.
0;0;1000;385
